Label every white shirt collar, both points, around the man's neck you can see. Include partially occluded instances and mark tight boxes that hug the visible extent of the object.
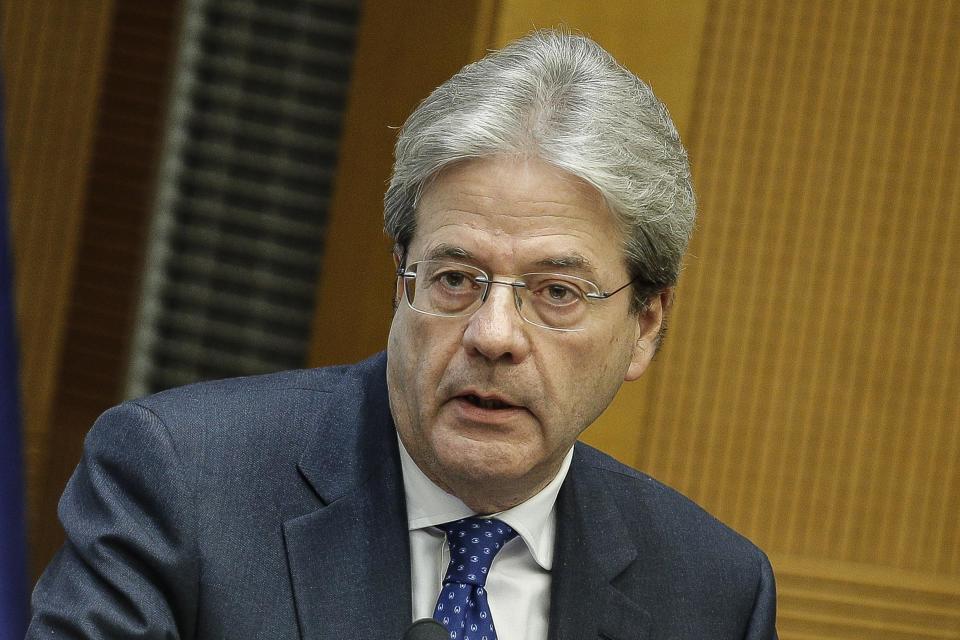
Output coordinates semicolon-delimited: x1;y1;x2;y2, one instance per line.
397;436;573;571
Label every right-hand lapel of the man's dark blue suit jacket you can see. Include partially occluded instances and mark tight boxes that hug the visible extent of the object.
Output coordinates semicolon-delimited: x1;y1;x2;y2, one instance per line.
549;445;650;640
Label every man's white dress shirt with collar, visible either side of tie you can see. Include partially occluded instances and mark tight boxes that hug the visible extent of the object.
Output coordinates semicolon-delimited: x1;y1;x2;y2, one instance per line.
397;438;573;640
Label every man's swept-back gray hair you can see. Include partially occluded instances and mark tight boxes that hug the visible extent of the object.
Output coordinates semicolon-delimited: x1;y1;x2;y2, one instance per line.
384;30;696;310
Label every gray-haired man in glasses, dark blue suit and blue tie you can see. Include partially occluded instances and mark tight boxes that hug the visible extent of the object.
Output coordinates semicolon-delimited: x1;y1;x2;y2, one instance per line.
28;32;776;640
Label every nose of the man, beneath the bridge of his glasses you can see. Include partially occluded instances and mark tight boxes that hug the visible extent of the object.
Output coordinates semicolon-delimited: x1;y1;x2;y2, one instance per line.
463;284;532;362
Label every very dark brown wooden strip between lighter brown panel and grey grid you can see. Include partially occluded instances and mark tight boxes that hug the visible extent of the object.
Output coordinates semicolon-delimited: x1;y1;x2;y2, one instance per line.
30;0;180;575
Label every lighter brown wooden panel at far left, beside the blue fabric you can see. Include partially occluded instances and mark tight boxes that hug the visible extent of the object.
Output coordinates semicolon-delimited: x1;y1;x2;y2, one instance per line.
0;0;113;576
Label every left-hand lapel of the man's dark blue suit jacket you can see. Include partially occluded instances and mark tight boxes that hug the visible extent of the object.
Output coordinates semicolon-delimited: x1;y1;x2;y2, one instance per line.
284;356;411;640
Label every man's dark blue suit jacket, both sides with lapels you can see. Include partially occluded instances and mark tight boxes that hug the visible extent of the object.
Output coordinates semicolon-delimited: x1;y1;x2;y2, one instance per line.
27;354;776;640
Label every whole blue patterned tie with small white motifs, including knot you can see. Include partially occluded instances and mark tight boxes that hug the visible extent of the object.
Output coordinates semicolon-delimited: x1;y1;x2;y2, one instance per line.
433;518;517;640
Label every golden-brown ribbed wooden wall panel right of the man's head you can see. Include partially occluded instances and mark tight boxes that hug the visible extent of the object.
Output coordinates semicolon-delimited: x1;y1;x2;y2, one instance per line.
636;2;960;575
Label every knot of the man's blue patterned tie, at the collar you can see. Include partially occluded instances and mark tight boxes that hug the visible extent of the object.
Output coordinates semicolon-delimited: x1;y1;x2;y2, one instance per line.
439;518;517;587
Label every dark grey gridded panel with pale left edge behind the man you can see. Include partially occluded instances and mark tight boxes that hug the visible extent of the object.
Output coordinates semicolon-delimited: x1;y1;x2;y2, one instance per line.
126;0;360;395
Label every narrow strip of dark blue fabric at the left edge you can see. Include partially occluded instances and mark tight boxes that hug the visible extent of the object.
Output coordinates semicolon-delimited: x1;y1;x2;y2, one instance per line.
0;82;27;640
